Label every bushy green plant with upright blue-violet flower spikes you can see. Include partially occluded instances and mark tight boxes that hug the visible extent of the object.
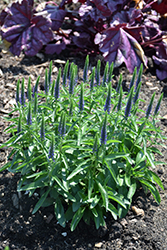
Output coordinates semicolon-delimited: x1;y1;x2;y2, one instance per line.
1;57;164;231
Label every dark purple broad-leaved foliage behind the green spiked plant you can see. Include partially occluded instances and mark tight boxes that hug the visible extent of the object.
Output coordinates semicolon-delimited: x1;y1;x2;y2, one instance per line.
0;0;167;80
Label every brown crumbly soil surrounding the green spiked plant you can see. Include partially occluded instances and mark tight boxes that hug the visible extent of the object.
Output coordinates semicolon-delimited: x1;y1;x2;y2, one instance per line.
0;1;167;250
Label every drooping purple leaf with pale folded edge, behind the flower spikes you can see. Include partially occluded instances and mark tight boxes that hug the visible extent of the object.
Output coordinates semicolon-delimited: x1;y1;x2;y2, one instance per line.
95;24;147;73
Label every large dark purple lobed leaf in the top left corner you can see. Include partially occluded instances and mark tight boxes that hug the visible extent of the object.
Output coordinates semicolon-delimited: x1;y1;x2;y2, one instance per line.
1;0;53;56
